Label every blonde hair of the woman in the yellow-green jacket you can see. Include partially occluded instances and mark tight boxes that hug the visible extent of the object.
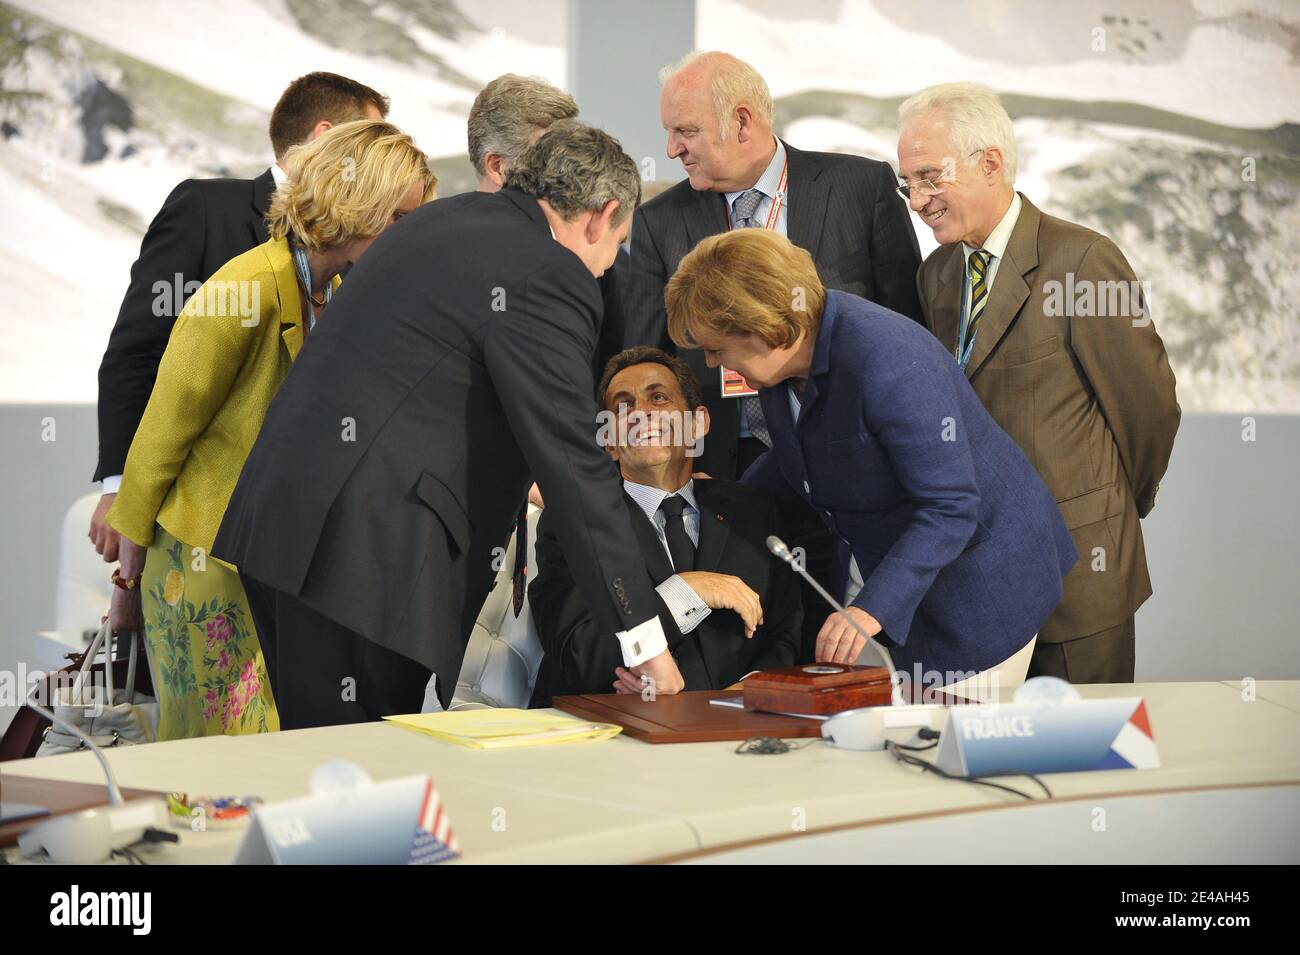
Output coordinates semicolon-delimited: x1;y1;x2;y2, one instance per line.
267;120;438;252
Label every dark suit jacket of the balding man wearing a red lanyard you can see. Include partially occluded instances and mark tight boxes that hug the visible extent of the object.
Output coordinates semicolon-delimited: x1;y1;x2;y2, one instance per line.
623;140;920;478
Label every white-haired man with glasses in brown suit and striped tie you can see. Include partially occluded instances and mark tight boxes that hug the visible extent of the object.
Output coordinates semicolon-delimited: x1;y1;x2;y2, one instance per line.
898;83;1180;683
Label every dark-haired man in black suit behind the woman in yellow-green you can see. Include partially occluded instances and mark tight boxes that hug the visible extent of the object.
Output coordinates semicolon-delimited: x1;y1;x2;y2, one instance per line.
90;73;389;563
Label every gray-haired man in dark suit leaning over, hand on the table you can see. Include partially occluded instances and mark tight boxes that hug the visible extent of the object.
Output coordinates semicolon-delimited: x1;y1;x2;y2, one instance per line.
213;120;683;728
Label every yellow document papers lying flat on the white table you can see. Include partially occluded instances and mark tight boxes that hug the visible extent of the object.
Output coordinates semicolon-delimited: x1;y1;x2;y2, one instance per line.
384;709;623;750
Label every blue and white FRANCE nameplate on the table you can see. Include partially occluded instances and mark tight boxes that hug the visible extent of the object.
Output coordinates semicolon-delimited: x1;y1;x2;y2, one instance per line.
935;696;1160;776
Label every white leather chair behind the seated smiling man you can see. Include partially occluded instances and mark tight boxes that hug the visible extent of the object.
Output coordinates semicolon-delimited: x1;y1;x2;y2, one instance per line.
424;507;542;712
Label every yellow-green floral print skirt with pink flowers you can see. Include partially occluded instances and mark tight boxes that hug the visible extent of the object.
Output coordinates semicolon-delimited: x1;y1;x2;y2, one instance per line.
140;526;280;741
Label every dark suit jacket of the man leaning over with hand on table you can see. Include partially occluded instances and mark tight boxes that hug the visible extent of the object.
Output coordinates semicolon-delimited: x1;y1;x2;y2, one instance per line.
213;190;658;704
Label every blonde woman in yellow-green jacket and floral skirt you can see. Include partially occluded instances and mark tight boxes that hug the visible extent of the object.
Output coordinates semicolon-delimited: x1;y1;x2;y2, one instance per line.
107;120;437;739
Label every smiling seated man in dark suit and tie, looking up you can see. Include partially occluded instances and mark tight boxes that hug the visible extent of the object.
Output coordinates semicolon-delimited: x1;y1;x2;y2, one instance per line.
528;347;803;706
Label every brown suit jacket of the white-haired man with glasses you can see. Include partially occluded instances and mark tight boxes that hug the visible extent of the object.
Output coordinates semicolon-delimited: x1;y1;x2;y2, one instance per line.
918;196;1180;643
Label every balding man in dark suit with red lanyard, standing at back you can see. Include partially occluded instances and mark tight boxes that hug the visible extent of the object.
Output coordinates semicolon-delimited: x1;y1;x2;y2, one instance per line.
623;52;920;478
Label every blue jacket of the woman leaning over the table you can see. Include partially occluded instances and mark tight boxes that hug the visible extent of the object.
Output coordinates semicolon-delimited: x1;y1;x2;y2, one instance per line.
745;291;1076;682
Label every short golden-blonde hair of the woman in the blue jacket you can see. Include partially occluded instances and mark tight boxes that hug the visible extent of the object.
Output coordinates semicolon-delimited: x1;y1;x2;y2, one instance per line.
664;229;826;348
